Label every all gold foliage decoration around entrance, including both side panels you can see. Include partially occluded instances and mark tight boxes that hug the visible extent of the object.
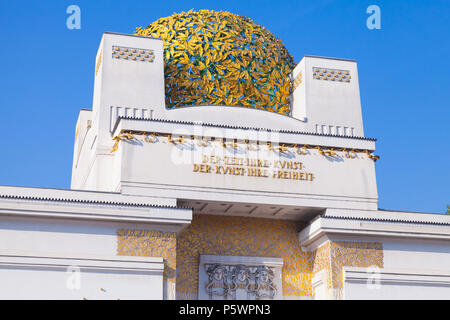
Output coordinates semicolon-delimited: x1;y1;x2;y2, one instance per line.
117;220;383;298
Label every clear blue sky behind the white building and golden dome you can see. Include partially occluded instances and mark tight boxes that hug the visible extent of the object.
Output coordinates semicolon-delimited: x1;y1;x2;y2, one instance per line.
0;0;450;213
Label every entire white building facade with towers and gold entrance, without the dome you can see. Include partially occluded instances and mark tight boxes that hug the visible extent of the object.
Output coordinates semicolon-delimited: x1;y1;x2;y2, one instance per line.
0;33;450;300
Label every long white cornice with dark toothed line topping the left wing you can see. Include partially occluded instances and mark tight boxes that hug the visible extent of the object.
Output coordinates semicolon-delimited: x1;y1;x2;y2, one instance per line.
0;187;192;227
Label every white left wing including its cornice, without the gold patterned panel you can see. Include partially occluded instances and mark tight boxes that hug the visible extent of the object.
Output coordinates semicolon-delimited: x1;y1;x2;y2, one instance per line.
0;187;192;299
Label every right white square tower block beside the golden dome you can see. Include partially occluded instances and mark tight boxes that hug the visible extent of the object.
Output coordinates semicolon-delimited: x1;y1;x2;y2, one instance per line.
292;56;364;137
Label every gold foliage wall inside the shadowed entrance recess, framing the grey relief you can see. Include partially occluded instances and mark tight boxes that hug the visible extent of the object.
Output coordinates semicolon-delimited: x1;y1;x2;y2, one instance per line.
177;215;314;297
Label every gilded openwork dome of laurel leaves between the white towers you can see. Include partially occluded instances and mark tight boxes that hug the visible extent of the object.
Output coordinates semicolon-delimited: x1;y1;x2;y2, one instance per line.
136;10;294;114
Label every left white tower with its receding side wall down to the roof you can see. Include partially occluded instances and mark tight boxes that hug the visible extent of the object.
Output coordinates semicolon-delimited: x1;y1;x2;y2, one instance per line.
71;32;165;191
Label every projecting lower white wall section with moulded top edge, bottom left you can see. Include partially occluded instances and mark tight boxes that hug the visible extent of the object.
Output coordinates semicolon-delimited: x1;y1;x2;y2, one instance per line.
0;255;163;300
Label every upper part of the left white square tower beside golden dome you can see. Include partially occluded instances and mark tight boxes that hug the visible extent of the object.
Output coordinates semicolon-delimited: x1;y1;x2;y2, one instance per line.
92;32;165;147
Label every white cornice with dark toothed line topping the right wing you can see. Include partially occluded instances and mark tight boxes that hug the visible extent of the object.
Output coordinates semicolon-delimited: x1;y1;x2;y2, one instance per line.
299;209;450;251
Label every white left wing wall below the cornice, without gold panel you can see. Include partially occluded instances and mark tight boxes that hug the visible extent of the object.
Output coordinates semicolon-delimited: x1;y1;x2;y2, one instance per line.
0;205;189;299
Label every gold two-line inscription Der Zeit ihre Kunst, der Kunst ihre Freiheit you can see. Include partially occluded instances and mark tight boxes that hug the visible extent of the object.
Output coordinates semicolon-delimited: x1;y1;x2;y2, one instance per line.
192;155;315;181
